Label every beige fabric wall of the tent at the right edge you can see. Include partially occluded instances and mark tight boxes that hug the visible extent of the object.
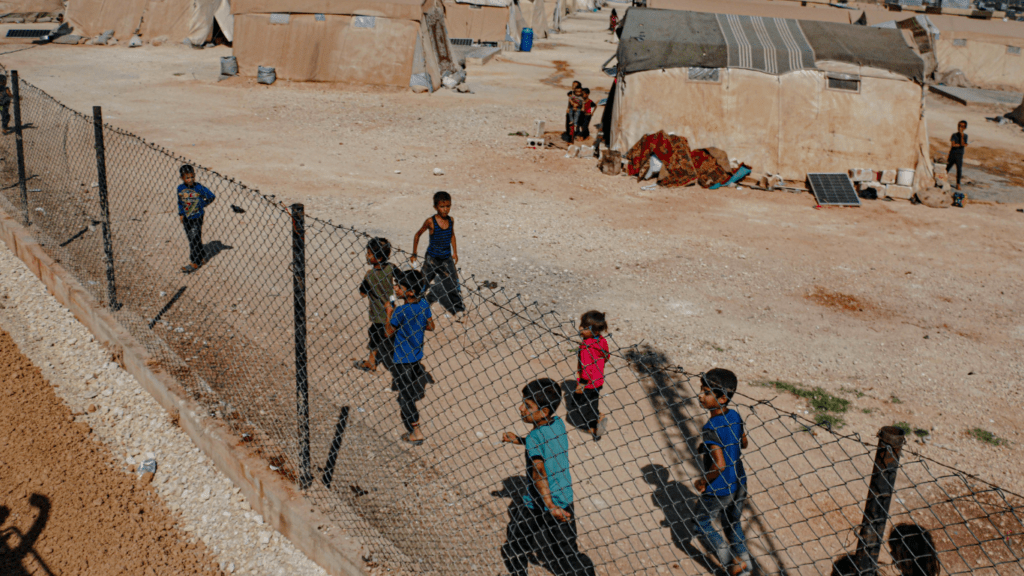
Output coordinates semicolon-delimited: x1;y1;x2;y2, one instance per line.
935;32;1024;92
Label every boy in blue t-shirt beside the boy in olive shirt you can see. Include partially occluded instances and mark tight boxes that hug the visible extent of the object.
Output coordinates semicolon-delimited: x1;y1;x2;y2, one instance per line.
386;270;434;446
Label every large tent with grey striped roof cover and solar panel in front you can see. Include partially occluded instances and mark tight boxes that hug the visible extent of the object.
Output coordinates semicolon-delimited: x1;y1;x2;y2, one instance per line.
610;8;934;189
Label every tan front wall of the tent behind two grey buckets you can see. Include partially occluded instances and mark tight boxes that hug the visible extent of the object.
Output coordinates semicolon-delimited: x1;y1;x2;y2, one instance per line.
233;13;420;87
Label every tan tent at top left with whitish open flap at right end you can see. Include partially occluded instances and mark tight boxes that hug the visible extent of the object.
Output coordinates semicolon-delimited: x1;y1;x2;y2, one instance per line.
66;0;231;46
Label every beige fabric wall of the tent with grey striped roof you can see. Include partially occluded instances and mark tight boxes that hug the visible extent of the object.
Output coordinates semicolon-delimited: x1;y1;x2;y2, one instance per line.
611;68;928;188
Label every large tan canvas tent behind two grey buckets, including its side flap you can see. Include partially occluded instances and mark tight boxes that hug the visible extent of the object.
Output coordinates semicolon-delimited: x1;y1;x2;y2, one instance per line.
231;0;459;89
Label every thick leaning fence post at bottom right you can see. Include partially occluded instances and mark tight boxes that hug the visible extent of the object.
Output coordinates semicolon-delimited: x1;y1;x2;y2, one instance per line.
854;426;906;576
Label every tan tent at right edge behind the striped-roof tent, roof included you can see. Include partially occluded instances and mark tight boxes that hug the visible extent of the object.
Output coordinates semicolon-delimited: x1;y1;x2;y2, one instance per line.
868;14;1024;92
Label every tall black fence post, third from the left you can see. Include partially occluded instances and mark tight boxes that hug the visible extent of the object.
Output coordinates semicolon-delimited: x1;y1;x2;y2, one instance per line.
291;204;313;489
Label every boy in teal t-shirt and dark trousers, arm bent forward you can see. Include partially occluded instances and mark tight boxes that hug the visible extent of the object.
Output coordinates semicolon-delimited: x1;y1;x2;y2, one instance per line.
502;378;594;576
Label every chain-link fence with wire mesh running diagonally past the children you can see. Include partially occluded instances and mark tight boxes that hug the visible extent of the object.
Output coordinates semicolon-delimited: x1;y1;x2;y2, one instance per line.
0;67;1024;576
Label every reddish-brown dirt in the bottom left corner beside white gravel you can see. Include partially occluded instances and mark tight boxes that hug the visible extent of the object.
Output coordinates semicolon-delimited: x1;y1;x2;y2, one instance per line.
0;331;220;576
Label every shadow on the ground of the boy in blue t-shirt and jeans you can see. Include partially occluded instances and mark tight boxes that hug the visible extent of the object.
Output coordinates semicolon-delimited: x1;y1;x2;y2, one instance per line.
640;464;725;576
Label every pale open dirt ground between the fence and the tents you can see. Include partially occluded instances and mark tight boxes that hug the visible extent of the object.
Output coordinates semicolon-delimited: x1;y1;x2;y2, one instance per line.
0;7;1024;569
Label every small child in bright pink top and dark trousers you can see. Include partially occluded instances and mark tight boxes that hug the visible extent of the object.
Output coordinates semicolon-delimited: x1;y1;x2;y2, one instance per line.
575;310;609;440
